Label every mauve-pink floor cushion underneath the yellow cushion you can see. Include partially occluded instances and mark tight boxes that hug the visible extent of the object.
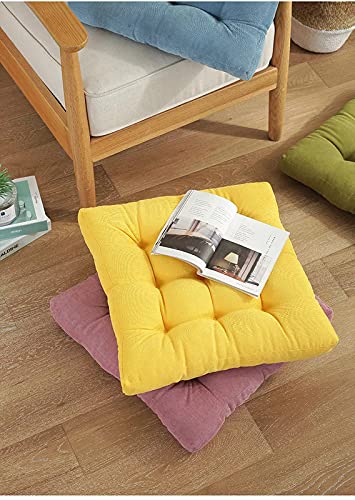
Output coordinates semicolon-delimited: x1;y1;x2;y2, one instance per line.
50;274;333;452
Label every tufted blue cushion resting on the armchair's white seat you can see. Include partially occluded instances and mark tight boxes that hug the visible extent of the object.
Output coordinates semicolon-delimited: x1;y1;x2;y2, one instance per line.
69;2;278;80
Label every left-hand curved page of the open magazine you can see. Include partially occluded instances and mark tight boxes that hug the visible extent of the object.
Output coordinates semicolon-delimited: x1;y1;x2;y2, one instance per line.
152;190;237;269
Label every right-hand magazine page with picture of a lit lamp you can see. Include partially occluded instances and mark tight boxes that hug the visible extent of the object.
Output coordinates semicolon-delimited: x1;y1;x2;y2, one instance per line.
201;214;289;297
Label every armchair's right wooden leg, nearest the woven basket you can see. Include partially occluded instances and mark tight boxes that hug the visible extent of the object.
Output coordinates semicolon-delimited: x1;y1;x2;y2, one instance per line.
269;2;292;141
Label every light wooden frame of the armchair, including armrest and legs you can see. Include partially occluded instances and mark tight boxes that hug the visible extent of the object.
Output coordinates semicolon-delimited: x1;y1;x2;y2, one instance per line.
0;2;291;207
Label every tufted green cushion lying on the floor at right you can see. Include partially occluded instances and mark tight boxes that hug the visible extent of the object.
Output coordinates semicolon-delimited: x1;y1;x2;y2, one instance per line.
281;99;355;213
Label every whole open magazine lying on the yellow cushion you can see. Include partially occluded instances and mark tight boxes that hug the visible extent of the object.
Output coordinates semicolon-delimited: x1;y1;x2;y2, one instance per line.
152;190;290;297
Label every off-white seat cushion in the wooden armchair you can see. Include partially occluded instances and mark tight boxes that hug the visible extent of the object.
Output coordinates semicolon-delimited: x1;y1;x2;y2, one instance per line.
0;2;274;136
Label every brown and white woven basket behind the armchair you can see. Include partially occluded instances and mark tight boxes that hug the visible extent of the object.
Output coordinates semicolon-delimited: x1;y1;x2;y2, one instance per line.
291;2;355;53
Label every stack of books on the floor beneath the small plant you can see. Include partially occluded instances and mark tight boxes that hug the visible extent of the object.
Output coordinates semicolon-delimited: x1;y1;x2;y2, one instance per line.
0;176;51;260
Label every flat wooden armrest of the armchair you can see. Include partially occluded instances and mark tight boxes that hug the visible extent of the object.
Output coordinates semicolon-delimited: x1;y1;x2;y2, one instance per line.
27;2;88;52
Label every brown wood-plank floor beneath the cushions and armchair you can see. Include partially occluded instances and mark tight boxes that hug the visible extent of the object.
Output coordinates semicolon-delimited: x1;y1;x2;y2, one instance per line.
0;36;355;494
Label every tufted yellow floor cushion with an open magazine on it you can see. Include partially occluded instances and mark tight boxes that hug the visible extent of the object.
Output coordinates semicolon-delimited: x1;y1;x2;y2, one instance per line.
79;182;338;395
